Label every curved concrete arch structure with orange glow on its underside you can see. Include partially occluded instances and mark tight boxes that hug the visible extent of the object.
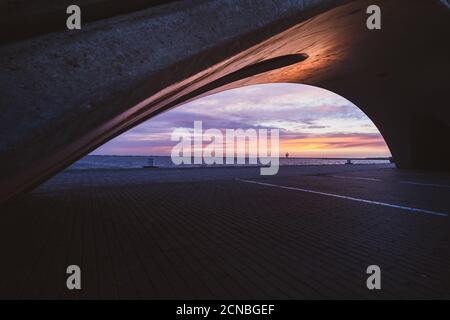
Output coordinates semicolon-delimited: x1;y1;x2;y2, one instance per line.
0;0;450;200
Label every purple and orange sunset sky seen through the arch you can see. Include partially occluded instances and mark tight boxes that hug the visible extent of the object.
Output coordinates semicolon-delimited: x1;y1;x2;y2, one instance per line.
91;84;390;157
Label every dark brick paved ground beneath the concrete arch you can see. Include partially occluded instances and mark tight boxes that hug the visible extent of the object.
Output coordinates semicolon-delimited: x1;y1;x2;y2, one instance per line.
0;165;450;299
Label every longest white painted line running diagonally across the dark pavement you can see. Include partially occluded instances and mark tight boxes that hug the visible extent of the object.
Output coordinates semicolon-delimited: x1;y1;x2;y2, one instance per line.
236;178;448;217
